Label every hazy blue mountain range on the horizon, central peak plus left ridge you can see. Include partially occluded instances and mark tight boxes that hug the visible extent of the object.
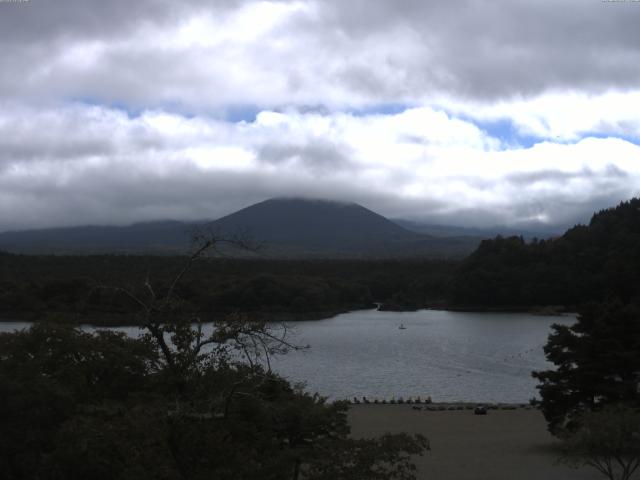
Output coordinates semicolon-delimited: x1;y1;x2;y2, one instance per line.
0;198;479;258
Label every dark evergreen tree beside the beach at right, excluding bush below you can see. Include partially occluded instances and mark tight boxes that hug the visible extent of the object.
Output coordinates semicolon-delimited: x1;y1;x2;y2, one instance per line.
533;302;640;433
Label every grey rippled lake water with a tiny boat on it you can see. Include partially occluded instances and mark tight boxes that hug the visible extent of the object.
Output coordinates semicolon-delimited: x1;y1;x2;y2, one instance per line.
0;310;575;403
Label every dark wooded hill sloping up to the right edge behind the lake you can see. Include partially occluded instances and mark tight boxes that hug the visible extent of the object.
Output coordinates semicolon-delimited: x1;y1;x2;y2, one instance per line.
452;198;640;306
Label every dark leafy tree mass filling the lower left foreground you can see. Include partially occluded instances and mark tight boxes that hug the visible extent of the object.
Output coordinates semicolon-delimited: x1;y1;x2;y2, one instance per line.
0;320;426;480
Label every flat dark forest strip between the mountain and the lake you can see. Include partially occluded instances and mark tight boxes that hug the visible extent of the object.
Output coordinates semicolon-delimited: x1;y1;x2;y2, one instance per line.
0;254;456;324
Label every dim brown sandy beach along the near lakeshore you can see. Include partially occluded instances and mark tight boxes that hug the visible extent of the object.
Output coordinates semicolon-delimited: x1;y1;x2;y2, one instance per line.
349;404;601;480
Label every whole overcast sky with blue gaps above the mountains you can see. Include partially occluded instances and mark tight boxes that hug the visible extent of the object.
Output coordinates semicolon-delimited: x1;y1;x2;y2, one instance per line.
0;0;640;231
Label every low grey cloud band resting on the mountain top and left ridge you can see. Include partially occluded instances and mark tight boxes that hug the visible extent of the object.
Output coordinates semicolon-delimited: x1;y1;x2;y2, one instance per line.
0;152;416;231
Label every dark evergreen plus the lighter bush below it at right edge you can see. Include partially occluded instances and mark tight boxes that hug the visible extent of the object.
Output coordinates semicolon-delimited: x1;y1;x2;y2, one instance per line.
533;301;640;480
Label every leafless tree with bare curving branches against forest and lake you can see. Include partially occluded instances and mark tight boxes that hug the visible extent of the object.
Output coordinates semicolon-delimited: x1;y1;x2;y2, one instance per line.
101;228;306;375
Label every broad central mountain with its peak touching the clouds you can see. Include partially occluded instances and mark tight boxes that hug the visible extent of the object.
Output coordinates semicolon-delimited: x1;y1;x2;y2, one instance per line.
192;198;480;258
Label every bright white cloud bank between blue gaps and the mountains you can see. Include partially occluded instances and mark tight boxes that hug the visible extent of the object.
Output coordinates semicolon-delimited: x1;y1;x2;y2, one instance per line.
0;104;640;229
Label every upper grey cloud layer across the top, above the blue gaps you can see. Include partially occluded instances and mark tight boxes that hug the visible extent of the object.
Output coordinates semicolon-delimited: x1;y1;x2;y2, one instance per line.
0;0;640;111
